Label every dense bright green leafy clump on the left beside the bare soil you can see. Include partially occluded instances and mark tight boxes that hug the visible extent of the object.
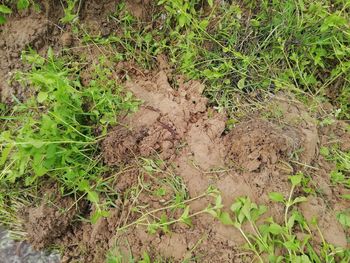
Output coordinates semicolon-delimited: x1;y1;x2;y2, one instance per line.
0;49;139;226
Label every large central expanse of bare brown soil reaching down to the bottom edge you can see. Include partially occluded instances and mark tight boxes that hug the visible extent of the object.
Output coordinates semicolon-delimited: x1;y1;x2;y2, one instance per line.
17;63;348;262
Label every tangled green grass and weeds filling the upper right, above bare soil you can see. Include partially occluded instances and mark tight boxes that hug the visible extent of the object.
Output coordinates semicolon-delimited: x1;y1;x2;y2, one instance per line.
80;0;350;118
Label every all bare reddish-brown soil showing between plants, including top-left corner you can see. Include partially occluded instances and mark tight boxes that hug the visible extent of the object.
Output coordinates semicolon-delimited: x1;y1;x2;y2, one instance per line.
0;0;350;262
